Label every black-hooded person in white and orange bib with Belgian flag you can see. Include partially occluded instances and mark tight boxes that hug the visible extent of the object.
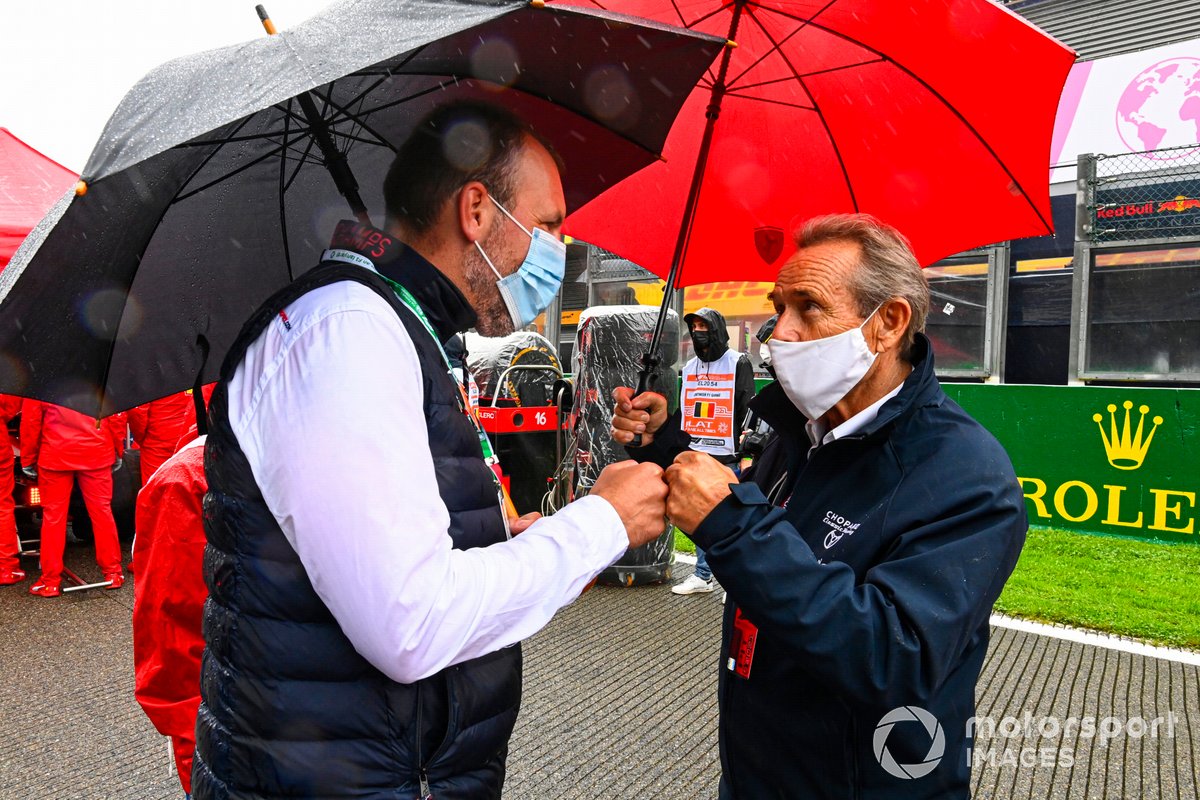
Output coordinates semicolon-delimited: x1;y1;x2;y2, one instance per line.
667;307;754;595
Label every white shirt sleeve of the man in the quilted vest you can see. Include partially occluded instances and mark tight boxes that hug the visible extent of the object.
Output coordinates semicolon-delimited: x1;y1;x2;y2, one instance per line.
229;282;629;684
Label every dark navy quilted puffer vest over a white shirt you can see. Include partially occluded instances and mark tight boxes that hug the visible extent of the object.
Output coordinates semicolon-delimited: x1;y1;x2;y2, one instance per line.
192;223;521;800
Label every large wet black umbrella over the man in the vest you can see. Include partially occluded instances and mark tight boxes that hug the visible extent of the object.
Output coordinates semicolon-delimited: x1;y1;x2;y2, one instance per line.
0;0;724;415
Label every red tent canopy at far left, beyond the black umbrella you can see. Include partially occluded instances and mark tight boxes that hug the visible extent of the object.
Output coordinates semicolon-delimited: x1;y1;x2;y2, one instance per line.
0;128;79;270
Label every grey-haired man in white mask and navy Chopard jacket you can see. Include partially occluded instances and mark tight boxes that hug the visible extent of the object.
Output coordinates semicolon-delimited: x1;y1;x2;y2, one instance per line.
613;215;1027;800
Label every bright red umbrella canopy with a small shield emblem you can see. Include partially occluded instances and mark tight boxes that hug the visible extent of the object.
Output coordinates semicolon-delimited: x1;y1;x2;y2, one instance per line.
556;0;1074;285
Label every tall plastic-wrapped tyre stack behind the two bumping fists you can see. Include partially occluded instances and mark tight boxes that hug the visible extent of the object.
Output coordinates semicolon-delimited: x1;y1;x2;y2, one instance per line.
572;306;679;587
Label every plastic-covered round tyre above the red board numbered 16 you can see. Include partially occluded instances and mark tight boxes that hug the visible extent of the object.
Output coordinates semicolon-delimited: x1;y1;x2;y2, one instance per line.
464;331;563;407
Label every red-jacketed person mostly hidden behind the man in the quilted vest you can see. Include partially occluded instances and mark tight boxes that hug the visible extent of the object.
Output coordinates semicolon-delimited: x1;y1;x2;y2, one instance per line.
133;428;209;794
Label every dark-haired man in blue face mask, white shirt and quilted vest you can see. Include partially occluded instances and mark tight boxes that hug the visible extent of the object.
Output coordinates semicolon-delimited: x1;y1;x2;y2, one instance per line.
192;104;666;799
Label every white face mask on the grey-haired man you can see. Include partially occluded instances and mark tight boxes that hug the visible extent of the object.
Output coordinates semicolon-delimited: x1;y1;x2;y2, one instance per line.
767;306;880;420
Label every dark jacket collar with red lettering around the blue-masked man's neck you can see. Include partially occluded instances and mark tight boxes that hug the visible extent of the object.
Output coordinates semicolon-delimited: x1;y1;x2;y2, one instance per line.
326;219;479;342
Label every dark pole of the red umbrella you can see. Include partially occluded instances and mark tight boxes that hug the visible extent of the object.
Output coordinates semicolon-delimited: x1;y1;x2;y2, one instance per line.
629;0;749;447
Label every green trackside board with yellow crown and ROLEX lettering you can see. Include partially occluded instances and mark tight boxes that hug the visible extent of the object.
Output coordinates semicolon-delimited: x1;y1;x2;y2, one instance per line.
943;384;1200;543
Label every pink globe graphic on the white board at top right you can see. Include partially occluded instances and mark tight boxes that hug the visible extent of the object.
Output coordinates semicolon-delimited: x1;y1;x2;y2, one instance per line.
1117;56;1200;158
